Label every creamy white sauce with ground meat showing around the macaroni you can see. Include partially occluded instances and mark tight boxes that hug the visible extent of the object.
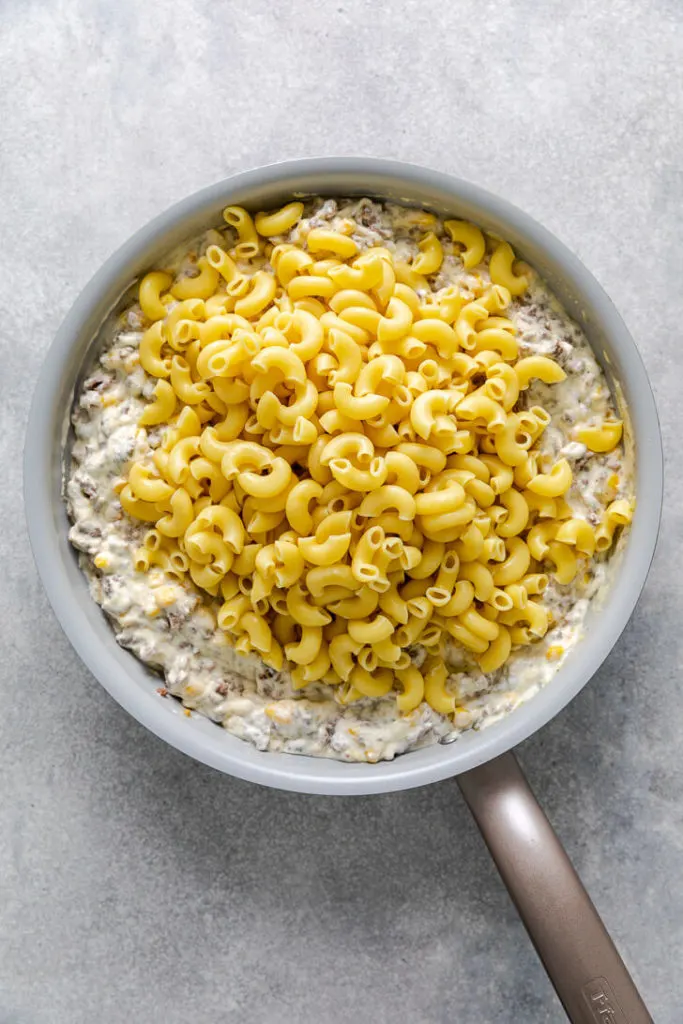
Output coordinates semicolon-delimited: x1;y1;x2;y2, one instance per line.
66;200;632;762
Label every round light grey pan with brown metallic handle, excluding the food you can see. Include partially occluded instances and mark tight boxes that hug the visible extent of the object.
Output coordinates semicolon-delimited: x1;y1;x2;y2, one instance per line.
25;158;663;1024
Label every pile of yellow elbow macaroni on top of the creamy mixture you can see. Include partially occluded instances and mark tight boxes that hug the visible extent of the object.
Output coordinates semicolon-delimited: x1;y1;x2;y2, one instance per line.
119;203;631;714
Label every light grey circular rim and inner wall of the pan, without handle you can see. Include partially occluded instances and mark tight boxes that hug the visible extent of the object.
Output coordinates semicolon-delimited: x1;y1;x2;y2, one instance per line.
24;157;664;796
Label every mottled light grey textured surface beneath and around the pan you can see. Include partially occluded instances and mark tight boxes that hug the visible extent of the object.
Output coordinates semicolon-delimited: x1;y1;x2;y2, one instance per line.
0;0;683;1024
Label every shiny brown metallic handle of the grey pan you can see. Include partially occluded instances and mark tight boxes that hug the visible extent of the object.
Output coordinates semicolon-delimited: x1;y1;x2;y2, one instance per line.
458;754;652;1024
